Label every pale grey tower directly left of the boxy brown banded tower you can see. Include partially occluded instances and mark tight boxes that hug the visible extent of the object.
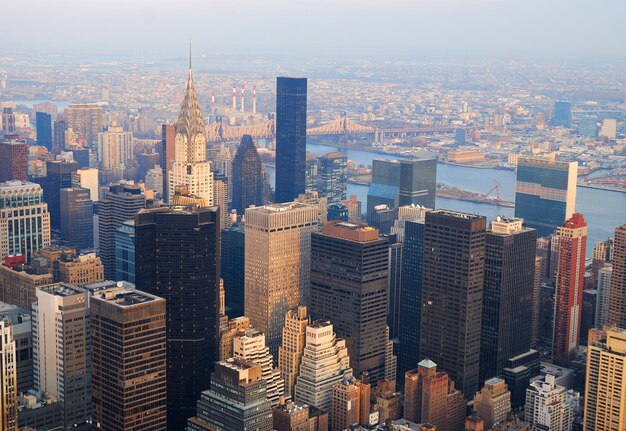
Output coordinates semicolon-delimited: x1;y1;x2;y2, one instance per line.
32;283;92;429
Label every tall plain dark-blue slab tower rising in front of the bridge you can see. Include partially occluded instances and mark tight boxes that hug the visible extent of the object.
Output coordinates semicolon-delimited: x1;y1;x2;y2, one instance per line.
275;78;307;203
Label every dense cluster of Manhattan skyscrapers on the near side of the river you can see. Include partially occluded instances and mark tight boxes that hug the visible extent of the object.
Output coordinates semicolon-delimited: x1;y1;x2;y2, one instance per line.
0;55;626;431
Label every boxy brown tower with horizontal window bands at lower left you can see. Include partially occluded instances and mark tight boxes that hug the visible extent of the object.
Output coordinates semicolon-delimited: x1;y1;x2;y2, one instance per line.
87;282;166;431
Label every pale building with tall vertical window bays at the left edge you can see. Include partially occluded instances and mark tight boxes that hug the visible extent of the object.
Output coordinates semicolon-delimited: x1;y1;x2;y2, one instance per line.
0;181;50;260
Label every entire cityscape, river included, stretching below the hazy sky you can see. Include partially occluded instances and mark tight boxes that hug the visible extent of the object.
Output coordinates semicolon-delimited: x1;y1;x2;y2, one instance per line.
0;47;626;431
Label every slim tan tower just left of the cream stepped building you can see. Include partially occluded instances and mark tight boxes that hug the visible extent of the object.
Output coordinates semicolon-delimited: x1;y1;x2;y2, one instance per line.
278;305;311;397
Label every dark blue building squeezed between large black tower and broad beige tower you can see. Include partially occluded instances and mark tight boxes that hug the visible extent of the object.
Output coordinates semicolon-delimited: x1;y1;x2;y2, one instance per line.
220;222;246;319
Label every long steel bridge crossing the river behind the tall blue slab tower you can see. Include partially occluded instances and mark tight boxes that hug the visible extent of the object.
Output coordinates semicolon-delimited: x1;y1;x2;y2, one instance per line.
207;112;456;143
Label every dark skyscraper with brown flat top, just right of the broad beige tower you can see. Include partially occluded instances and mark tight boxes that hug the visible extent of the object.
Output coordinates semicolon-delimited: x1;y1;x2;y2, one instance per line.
310;222;389;383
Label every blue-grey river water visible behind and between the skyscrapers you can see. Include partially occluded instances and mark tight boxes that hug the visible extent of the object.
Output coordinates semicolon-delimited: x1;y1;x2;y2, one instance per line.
271;144;626;256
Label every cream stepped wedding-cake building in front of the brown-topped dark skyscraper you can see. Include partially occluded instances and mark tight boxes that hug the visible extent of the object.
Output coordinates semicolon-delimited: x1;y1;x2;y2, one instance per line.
294;320;352;412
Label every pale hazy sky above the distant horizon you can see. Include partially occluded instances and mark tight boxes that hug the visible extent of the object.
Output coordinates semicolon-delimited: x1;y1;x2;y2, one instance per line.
0;0;626;61
